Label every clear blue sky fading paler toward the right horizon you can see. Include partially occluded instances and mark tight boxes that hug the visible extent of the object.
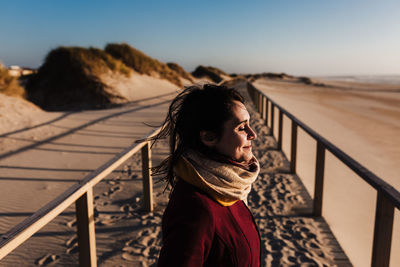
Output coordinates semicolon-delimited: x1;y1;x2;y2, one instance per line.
0;0;400;75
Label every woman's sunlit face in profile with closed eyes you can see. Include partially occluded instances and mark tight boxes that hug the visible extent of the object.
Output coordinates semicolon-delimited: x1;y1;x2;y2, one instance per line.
214;101;257;162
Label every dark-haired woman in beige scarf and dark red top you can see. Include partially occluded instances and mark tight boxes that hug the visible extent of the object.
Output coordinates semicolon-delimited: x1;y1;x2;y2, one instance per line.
155;84;261;266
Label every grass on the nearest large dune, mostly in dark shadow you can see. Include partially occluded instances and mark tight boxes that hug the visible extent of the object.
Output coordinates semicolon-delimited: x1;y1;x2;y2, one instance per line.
27;47;132;110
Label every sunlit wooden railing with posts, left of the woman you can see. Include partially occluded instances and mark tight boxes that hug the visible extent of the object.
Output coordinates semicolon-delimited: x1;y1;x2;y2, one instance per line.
0;128;160;266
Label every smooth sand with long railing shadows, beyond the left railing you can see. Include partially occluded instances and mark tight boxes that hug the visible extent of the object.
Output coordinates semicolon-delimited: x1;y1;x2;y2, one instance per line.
0;75;178;266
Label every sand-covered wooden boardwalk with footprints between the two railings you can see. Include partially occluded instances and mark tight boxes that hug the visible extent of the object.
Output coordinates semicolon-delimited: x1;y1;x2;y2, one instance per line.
0;81;352;266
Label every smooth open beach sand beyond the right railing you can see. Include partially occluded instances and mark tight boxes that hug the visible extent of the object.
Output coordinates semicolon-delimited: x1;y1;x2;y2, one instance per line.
254;79;400;266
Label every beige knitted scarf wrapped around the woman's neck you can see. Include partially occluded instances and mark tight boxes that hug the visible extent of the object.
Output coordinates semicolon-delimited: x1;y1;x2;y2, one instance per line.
174;151;260;206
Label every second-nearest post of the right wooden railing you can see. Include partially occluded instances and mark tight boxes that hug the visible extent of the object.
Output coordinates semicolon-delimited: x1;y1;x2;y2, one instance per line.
313;141;325;217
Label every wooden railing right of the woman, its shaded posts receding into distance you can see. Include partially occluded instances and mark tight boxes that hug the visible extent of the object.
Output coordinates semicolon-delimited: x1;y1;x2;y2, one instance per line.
247;82;400;267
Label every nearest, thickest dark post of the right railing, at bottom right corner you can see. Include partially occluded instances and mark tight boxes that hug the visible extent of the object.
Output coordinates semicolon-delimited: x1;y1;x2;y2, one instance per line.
371;191;394;267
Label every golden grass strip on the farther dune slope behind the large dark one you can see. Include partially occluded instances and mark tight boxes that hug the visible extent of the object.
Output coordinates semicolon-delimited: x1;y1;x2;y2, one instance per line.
104;43;182;86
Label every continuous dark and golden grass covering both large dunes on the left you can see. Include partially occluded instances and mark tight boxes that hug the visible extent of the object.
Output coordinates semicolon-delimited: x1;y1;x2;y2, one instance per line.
26;44;194;110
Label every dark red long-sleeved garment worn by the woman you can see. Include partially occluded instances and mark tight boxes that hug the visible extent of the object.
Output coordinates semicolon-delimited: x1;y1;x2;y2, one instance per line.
158;181;261;267
